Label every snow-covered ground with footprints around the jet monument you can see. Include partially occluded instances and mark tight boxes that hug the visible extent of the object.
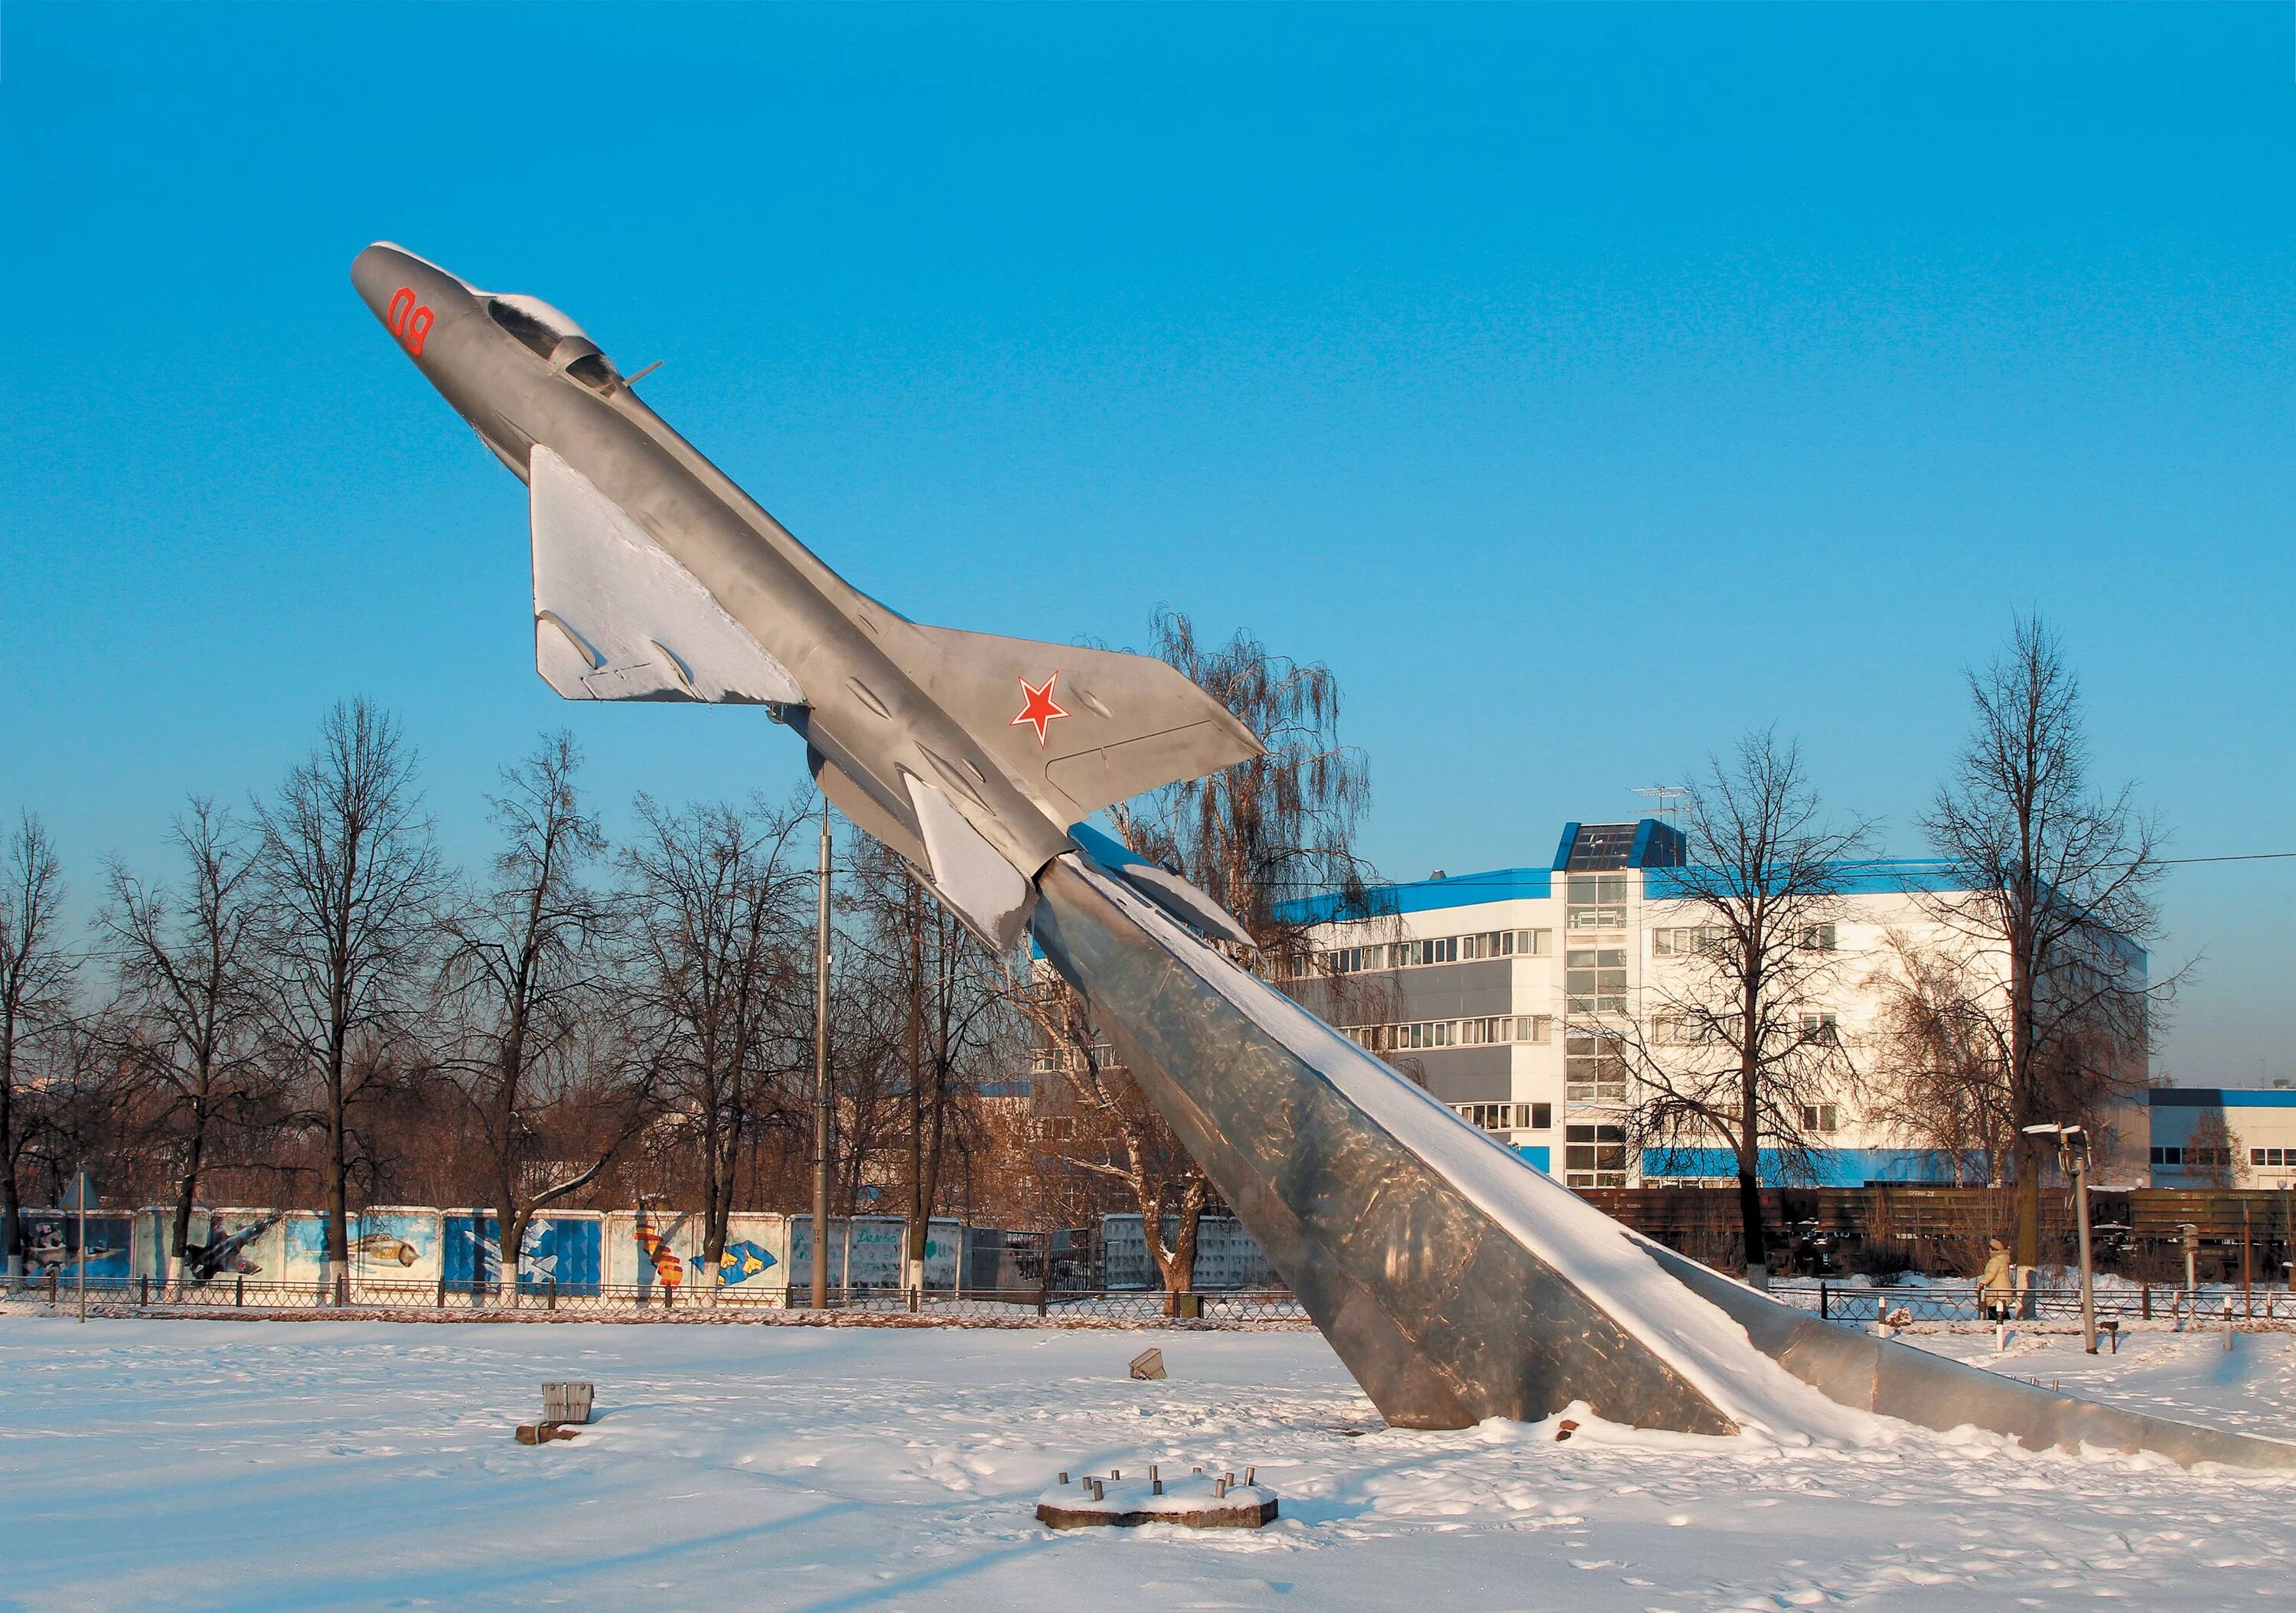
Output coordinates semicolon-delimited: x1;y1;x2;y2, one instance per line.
0;1314;2296;1613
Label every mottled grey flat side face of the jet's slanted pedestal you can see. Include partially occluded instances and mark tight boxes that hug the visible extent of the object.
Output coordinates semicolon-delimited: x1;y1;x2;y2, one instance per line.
1035;862;1738;1434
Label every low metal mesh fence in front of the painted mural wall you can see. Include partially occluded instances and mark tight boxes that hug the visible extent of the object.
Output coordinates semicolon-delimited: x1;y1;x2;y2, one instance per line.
0;1273;1306;1328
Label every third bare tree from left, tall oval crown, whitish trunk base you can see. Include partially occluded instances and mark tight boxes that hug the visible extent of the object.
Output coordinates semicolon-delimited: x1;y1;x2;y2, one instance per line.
257;698;441;1303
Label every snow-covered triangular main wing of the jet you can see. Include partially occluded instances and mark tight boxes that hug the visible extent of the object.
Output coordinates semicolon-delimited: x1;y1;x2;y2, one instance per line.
528;443;806;705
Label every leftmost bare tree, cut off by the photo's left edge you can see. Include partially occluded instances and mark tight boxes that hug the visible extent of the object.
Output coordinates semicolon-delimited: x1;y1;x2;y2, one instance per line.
0;814;78;1289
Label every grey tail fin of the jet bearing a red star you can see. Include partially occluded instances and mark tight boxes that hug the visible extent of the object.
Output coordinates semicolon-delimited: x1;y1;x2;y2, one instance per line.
886;622;1263;823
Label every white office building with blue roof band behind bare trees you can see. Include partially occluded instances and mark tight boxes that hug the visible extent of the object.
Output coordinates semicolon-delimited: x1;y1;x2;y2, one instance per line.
1283;818;2149;1188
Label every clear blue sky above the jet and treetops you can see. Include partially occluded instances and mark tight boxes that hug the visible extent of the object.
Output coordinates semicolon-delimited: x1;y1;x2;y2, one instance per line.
0;0;2296;1082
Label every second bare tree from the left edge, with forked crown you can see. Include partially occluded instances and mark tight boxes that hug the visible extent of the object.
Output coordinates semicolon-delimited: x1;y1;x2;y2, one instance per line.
99;797;262;1282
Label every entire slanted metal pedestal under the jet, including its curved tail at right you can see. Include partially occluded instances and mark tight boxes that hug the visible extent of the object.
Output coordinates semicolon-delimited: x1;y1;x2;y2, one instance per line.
1033;857;2296;1468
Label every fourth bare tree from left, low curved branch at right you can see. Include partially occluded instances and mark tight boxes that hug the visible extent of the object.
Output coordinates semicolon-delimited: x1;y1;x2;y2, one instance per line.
443;730;647;1305
